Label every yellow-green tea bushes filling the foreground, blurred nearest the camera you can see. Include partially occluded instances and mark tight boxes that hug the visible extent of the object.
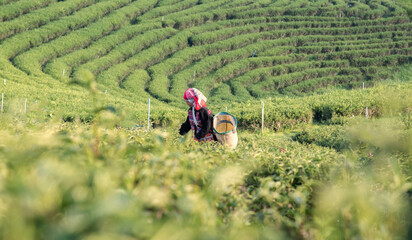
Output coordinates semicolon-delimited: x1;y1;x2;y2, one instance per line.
0;89;412;239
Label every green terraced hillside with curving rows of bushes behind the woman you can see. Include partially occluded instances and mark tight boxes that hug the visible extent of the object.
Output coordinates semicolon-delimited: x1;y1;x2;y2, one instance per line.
0;0;412;125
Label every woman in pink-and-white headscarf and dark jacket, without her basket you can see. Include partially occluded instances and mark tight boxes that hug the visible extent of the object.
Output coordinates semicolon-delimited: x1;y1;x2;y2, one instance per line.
179;88;215;142
